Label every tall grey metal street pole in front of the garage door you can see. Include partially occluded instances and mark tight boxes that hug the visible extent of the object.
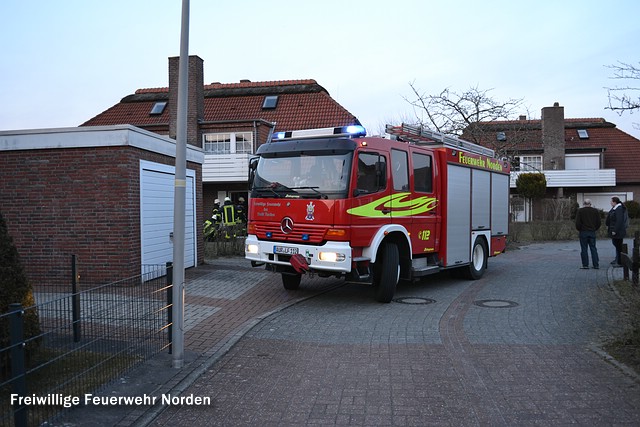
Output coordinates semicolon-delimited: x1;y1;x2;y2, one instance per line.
172;0;189;368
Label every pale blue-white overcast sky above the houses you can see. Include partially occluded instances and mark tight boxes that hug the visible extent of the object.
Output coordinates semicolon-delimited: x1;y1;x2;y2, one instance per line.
0;0;640;138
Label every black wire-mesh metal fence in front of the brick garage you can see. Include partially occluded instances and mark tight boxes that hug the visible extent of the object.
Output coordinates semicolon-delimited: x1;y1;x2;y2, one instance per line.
0;257;172;426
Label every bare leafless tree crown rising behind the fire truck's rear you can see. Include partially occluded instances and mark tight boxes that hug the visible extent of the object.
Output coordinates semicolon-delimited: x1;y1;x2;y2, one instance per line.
404;82;528;157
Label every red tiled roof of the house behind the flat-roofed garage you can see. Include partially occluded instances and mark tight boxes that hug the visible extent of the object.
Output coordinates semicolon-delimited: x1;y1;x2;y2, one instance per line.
81;79;356;130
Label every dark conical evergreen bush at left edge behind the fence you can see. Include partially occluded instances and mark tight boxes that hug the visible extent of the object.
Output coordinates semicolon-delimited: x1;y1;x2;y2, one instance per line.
0;213;40;376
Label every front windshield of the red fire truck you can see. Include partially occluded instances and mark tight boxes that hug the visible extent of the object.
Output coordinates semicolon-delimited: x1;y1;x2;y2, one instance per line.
251;152;353;199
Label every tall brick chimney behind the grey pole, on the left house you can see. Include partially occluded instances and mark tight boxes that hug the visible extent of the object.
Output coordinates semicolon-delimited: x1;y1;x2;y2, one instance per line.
169;55;204;148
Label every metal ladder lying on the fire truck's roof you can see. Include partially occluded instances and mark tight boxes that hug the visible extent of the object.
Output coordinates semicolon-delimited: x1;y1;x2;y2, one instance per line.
385;123;496;157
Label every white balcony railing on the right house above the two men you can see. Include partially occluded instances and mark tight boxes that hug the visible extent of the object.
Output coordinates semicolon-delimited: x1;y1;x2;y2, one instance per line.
509;169;616;188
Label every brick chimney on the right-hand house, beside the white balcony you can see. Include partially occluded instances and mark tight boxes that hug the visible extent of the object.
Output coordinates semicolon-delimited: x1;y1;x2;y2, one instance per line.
542;102;565;170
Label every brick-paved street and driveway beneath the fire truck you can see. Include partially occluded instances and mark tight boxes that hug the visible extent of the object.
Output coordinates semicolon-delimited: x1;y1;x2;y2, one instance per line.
60;242;640;426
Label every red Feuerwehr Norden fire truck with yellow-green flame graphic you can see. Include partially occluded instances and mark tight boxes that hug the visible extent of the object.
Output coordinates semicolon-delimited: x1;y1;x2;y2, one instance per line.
245;124;509;302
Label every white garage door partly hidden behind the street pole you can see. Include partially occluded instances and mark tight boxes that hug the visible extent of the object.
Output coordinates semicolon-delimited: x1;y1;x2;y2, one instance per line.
140;160;196;273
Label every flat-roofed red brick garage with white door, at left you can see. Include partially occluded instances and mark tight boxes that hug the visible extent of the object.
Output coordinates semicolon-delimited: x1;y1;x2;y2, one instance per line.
0;126;204;284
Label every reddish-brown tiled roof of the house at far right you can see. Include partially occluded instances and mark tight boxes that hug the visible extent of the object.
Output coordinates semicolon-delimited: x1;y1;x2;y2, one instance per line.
470;118;640;184
